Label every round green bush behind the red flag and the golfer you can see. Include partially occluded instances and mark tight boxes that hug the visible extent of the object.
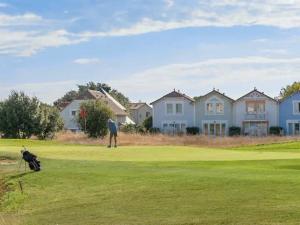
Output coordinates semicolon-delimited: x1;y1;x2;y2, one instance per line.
78;100;113;138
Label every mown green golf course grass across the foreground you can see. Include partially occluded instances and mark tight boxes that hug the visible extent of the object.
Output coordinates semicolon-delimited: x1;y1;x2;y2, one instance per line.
0;140;300;225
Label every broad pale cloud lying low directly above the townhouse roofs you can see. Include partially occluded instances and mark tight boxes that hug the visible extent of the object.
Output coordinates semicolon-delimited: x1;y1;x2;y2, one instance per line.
108;57;300;101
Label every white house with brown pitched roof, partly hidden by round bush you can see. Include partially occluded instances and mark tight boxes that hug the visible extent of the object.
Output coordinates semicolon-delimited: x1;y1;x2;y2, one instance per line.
60;89;134;131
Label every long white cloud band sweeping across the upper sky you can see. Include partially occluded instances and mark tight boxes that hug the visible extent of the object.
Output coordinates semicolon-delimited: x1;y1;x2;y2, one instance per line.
0;0;300;56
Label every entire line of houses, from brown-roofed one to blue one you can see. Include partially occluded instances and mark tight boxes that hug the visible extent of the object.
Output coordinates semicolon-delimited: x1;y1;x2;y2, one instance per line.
61;89;300;136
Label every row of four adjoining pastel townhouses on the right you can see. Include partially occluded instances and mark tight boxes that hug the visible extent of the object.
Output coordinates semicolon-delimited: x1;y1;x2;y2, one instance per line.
151;88;300;136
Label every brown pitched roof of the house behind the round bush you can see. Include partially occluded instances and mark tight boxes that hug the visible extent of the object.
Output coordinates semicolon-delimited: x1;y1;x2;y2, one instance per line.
77;89;128;116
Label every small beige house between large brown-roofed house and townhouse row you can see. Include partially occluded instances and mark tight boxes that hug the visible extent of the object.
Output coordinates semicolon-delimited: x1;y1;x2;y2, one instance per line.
129;102;152;125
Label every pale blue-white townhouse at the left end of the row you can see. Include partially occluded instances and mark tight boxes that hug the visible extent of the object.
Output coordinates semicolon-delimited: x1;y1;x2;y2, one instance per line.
151;90;195;133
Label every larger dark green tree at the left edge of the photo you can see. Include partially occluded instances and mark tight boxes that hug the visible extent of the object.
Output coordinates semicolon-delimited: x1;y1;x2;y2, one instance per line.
0;91;39;138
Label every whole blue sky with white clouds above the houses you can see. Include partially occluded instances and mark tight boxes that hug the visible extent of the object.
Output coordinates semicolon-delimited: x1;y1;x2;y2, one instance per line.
0;0;300;103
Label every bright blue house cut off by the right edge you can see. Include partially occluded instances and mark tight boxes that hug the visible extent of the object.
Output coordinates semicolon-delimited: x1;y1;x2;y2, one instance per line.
279;92;300;135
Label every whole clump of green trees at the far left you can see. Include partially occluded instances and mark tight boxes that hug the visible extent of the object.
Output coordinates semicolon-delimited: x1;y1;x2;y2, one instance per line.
0;91;63;139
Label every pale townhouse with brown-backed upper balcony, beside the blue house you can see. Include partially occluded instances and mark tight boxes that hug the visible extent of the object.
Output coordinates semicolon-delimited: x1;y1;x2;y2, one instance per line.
233;88;279;136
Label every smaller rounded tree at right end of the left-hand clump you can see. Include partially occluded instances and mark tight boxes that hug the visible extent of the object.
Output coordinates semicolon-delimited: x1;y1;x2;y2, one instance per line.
35;104;64;139
